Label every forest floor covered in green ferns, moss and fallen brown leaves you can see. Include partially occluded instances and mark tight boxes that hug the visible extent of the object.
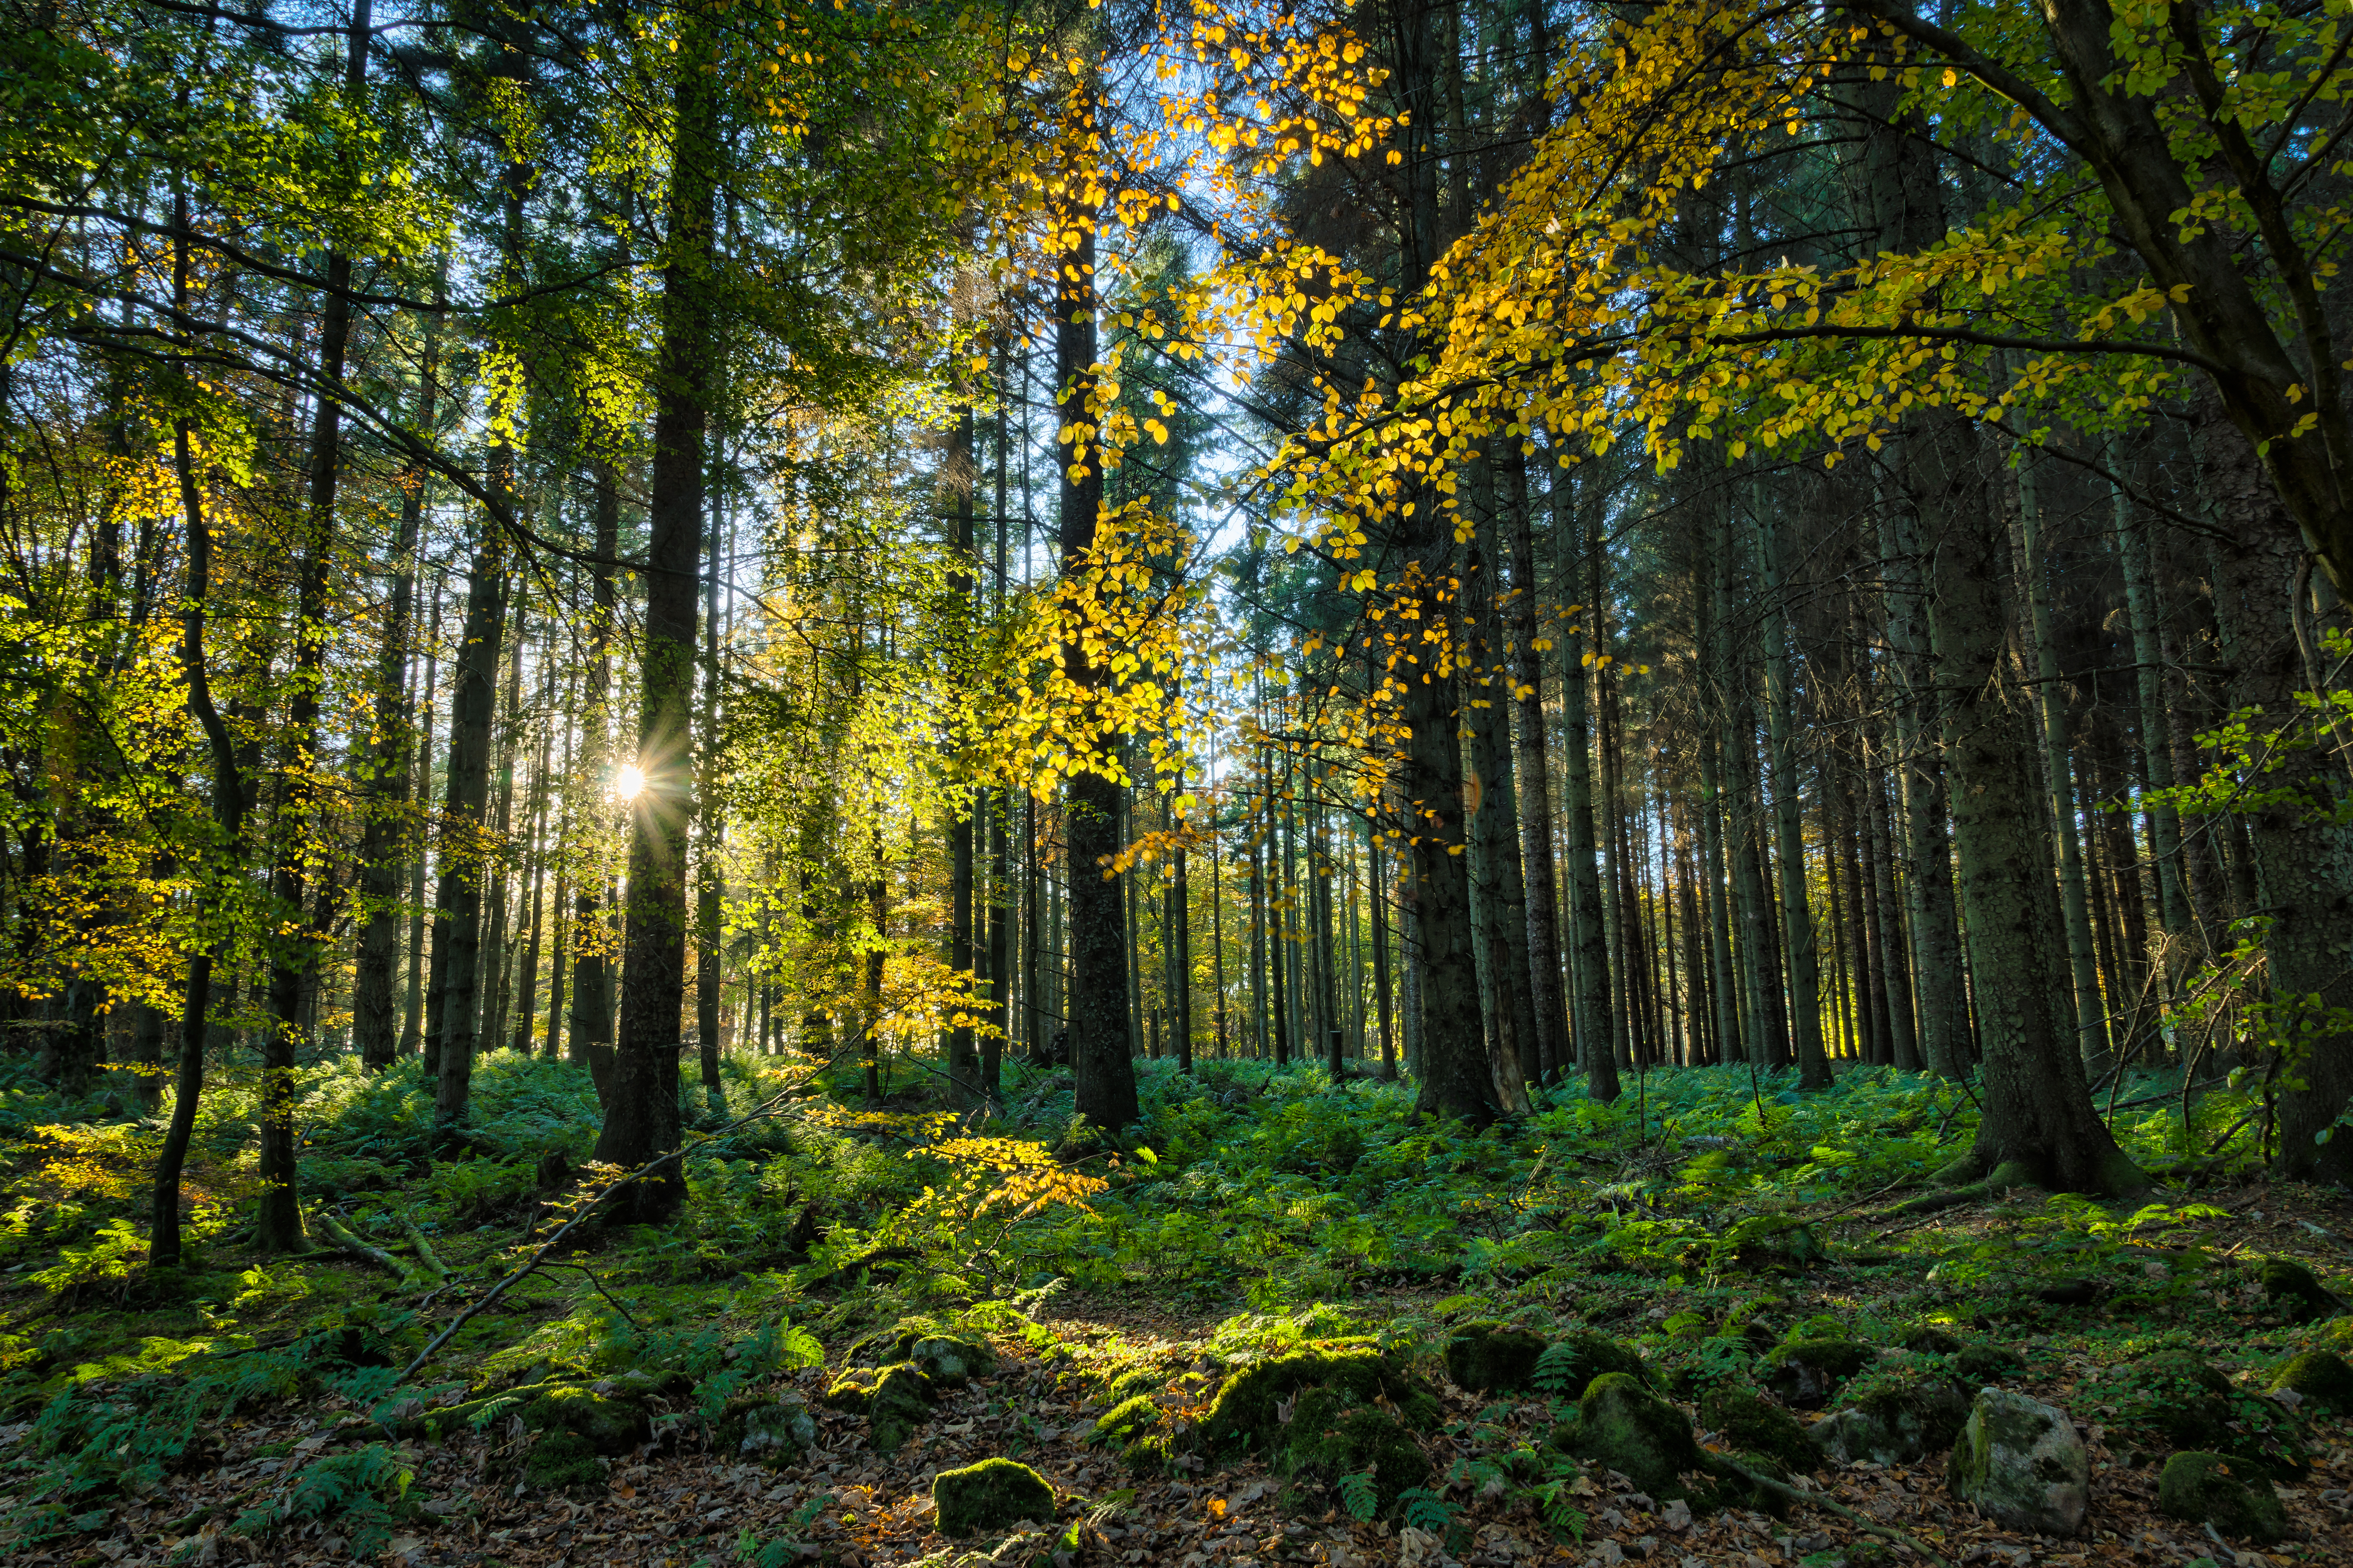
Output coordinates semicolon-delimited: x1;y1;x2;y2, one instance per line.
0;1058;2353;1568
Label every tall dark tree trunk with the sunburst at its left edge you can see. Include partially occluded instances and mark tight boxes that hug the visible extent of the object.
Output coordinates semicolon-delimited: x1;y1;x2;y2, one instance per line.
595;36;720;1222
